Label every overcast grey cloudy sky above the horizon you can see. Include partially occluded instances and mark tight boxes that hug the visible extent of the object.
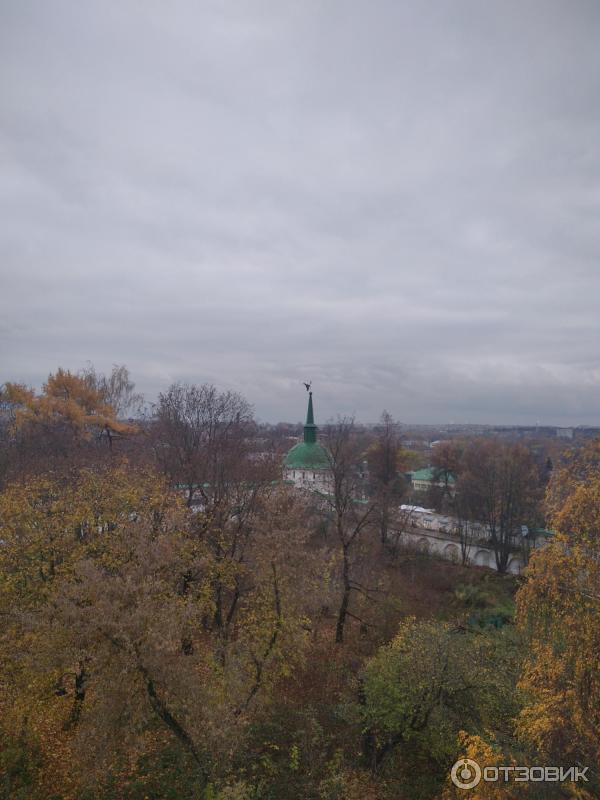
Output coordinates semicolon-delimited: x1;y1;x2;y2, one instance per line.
0;0;600;425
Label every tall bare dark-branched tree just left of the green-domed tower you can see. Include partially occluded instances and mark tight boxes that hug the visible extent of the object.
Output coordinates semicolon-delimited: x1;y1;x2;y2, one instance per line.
152;384;288;652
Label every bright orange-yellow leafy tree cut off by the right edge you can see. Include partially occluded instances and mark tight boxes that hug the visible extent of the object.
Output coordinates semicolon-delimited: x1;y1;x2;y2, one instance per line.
517;441;600;780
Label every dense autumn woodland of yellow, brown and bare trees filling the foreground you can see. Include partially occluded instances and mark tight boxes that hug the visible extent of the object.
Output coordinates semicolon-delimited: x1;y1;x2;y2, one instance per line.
0;367;600;800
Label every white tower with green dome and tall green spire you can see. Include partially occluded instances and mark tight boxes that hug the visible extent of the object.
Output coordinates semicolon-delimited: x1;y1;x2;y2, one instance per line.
283;391;331;493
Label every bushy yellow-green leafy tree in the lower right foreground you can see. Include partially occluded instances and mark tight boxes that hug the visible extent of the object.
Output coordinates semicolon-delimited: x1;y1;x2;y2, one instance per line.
362;618;518;796
